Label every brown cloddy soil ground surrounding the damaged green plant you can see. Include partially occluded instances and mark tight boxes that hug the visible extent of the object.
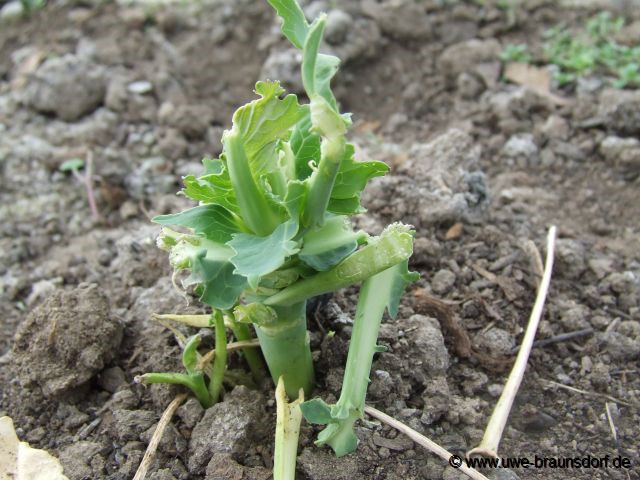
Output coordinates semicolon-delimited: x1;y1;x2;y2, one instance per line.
0;0;640;480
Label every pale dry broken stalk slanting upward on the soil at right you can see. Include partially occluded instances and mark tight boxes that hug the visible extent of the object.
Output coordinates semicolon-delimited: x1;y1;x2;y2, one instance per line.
467;226;556;458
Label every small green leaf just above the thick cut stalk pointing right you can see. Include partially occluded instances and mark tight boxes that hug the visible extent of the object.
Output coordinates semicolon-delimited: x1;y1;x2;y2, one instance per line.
298;216;367;271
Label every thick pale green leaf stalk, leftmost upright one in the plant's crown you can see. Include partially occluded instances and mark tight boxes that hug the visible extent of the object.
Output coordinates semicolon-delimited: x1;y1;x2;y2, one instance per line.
223;130;281;236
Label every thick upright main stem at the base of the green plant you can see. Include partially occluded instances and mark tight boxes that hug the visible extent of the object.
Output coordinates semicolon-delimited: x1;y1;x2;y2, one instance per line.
255;301;313;398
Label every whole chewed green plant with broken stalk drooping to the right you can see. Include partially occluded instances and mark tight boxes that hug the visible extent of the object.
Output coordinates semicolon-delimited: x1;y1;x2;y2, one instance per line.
153;0;417;455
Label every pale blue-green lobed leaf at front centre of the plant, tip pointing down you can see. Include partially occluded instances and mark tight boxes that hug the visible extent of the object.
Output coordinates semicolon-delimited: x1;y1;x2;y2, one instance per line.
227;220;299;289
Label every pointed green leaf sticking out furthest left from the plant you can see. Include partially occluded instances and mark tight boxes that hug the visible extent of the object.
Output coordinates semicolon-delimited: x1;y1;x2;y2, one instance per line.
152;205;247;243
